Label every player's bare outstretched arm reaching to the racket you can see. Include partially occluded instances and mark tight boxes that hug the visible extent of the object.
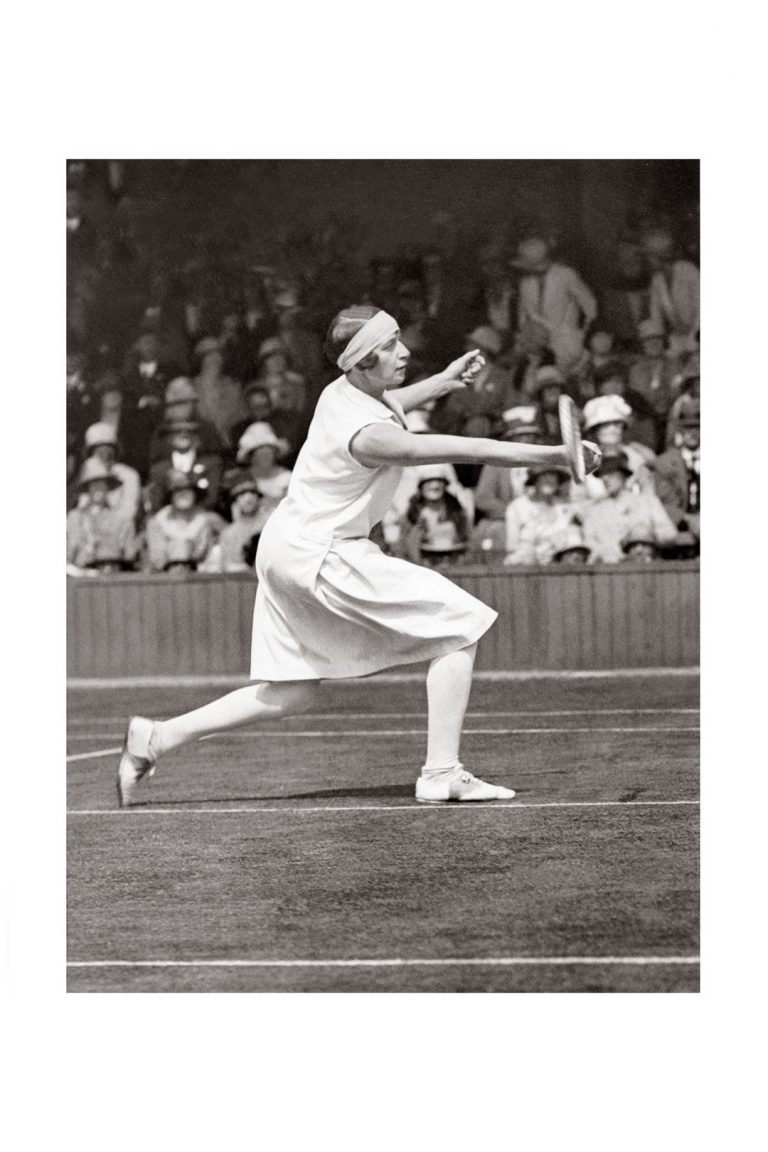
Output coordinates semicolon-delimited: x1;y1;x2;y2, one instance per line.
350;422;599;470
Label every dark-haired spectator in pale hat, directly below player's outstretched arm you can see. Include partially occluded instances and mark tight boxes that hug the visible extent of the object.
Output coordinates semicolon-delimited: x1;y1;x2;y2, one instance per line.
401;464;470;568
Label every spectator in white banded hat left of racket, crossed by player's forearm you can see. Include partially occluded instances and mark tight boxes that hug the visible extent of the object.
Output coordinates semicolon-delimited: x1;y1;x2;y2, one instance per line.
472;407;541;552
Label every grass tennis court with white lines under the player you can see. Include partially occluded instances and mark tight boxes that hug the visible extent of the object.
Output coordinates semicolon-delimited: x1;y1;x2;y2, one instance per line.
67;673;699;992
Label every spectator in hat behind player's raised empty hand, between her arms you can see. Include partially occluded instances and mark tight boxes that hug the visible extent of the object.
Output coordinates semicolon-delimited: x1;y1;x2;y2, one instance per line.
429;325;522;444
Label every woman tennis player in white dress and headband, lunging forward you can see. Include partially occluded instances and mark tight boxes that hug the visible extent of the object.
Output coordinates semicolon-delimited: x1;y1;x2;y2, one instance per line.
117;305;600;806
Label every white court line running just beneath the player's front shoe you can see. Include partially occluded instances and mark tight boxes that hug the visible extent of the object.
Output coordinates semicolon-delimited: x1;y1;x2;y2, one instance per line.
67;799;700;817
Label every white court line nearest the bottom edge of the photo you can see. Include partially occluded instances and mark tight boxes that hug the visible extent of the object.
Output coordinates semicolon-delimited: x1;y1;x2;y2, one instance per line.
67;956;700;968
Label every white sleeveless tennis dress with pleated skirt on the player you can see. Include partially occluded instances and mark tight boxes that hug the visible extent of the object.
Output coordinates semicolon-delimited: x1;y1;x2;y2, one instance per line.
251;376;497;681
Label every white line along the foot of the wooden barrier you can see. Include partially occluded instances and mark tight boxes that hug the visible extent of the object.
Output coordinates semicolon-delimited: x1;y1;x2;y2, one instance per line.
67;665;699;690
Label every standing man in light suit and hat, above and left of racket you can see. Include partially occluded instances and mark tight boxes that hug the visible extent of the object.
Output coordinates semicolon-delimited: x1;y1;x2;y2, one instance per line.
512;235;598;372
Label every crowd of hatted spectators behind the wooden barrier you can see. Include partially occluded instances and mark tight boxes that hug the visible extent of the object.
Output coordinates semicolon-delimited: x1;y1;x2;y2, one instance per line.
67;160;701;576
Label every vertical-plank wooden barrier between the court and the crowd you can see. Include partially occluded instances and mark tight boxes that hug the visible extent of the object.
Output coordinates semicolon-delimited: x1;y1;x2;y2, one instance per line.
67;561;699;679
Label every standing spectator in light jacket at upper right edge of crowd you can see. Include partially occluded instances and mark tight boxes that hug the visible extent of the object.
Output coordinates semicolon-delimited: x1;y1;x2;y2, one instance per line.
642;228;699;354
